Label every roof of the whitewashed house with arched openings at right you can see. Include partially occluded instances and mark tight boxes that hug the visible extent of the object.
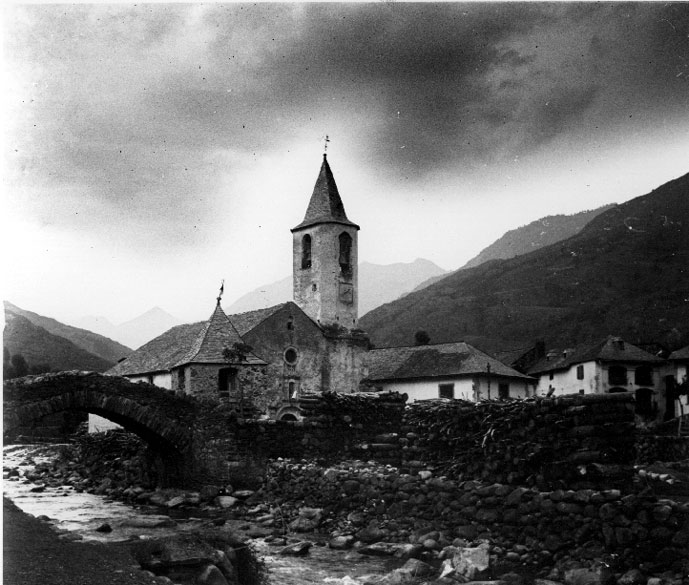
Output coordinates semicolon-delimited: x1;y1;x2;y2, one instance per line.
528;335;664;376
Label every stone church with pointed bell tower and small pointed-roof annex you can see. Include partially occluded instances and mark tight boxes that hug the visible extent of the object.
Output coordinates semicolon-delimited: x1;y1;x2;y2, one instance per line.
106;154;369;420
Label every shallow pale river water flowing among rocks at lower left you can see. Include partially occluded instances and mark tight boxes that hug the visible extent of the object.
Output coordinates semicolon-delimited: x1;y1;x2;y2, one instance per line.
3;445;393;585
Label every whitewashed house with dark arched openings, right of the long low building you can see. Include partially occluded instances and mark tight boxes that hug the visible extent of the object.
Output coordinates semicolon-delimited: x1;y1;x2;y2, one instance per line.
527;336;665;419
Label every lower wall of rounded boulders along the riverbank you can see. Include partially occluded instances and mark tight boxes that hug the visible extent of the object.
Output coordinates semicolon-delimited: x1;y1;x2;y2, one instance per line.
264;461;689;567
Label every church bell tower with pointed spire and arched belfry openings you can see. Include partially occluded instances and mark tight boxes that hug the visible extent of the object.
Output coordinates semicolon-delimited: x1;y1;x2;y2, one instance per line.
291;154;359;329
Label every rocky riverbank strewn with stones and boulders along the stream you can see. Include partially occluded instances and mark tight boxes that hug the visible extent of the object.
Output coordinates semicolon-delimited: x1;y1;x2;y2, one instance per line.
5;438;689;585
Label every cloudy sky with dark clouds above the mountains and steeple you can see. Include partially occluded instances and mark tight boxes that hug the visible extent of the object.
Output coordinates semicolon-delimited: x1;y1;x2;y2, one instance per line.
2;2;689;323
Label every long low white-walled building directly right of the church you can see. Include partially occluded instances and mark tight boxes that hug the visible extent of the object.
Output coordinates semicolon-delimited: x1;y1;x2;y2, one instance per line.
362;342;536;402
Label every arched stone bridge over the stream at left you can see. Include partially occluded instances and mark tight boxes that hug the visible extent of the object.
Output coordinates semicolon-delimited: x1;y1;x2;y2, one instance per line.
3;371;236;486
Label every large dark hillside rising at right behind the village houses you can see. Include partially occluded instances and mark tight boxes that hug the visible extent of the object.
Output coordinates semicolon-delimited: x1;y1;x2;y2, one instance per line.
360;175;689;351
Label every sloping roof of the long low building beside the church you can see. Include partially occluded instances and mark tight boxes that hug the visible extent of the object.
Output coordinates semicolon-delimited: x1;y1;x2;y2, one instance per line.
364;341;531;382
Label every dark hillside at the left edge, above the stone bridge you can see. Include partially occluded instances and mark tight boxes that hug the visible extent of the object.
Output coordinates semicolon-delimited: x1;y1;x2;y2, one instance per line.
3;308;113;372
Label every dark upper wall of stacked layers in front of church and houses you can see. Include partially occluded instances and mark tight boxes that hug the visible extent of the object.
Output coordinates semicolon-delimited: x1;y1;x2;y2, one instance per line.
238;393;634;489
